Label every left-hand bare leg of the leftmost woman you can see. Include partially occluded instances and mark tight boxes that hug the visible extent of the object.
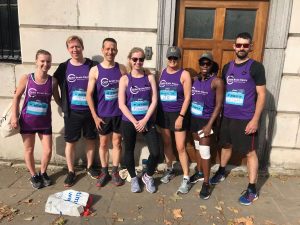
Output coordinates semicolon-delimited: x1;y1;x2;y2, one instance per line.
22;134;36;176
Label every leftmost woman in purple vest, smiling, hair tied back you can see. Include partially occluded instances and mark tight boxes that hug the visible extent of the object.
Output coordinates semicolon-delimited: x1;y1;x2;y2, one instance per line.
11;50;60;189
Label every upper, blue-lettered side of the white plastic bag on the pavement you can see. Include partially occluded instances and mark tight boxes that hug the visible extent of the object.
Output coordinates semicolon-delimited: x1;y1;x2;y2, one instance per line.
55;189;89;206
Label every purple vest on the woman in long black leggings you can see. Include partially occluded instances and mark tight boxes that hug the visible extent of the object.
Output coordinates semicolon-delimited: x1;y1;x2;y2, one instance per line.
122;74;152;122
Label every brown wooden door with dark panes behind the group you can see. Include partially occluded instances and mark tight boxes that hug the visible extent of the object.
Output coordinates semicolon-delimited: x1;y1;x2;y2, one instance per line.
176;0;269;165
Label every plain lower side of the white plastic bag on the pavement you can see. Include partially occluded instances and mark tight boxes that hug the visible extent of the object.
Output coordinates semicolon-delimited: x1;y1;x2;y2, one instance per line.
45;194;84;216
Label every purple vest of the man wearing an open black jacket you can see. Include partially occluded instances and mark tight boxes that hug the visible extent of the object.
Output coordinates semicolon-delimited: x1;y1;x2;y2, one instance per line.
66;61;90;110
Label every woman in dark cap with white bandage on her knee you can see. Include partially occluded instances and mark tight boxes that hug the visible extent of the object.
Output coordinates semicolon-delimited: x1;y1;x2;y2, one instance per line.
190;52;224;199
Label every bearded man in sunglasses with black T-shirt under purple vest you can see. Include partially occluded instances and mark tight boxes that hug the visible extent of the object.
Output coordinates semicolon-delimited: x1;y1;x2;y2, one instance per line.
210;33;266;205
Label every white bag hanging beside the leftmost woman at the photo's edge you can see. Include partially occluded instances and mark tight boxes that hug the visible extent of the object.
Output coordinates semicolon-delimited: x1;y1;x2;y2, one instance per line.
0;103;20;137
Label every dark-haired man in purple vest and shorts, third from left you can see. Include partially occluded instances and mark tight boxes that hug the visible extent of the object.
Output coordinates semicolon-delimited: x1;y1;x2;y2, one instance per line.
87;38;127;187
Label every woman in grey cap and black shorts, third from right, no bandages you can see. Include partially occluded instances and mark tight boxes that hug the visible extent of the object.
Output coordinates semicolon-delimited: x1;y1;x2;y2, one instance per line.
157;46;192;194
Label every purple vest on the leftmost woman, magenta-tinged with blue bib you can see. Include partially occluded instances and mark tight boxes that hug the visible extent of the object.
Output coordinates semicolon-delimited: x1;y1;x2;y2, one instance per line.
20;74;52;131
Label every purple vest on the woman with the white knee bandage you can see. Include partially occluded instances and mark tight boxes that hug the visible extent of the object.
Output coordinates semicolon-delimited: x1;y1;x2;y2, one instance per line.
191;75;216;119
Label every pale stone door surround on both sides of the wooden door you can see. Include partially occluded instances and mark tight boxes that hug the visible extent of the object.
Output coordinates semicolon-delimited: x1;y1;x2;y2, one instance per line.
156;0;293;167
